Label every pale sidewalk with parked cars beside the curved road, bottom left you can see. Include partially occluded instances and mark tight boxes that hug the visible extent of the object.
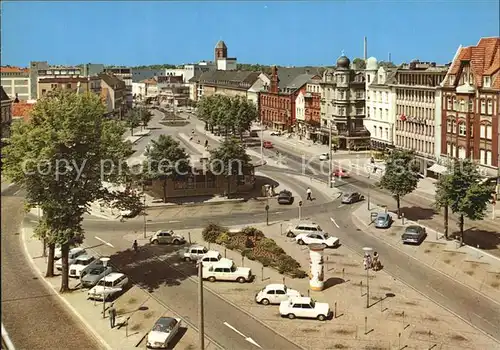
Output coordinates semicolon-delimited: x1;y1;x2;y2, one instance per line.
21;221;216;350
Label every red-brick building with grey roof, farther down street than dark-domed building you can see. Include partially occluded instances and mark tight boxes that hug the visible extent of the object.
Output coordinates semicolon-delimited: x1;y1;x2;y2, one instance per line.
259;66;321;132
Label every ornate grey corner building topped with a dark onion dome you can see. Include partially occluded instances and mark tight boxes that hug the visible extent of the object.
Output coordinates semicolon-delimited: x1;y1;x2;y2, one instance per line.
319;55;370;149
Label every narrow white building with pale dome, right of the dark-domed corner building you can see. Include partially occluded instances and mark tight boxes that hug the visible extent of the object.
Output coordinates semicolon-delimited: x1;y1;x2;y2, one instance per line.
364;57;397;149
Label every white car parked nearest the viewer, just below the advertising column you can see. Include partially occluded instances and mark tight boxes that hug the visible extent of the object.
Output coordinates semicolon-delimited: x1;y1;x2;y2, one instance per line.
280;297;331;321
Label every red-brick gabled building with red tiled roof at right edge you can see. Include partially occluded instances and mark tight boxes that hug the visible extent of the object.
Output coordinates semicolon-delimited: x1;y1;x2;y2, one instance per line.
440;37;500;176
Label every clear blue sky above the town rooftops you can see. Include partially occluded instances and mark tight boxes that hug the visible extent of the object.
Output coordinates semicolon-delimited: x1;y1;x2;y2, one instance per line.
0;0;500;66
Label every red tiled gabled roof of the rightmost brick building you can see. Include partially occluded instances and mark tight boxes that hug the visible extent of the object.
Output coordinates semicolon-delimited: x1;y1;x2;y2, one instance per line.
449;37;500;88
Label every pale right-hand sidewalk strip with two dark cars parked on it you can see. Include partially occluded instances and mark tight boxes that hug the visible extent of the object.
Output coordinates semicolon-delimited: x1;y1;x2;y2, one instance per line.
352;203;500;300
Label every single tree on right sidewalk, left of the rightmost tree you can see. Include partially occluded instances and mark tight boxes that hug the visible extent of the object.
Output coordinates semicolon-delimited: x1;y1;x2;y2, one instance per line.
380;150;419;218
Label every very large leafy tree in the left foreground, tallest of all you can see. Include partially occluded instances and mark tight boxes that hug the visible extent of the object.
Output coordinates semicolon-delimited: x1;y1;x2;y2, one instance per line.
2;91;139;292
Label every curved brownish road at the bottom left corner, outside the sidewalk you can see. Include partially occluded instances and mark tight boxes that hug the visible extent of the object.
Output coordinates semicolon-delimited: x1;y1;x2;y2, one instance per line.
1;185;103;350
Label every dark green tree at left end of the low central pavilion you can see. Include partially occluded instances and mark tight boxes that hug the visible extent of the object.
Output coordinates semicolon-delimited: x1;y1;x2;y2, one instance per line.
143;135;190;203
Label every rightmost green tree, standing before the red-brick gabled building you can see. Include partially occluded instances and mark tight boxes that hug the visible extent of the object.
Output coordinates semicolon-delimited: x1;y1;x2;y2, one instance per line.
436;159;494;244
